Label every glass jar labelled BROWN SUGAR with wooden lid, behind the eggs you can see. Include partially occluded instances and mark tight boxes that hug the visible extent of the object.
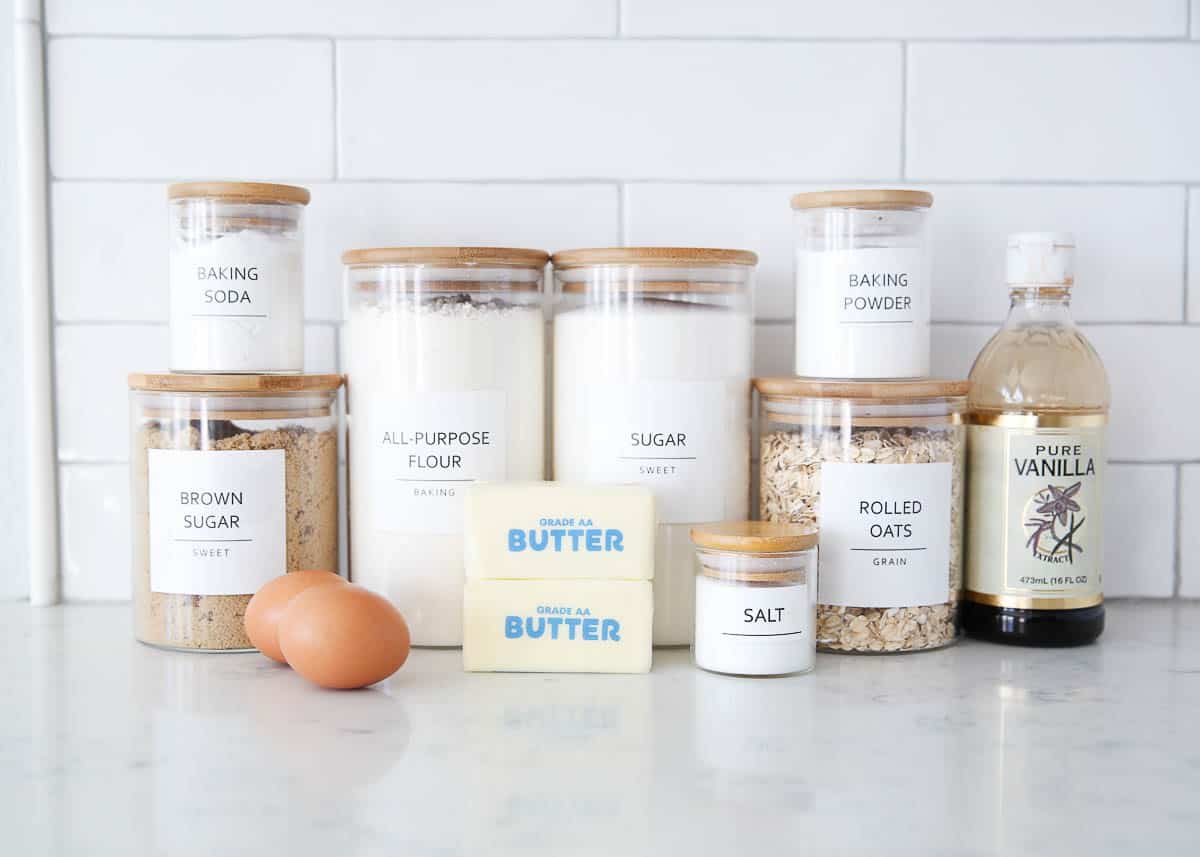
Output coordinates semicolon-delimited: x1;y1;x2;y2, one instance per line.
130;374;342;651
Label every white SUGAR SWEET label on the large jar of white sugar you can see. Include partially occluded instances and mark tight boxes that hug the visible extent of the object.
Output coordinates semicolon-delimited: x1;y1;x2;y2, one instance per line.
589;380;724;523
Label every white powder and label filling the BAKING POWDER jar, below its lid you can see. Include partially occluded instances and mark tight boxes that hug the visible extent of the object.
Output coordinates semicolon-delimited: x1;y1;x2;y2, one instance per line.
796;247;930;378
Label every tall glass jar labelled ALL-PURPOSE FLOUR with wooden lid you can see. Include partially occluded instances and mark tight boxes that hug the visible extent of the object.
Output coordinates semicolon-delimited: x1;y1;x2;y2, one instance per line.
342;247;548;646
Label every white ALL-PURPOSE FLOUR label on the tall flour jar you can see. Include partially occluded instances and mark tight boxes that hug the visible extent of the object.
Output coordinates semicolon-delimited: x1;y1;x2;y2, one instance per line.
350;390;508;534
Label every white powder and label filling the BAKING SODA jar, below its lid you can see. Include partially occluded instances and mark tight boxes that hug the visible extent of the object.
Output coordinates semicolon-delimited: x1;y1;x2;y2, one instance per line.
170;229;304;372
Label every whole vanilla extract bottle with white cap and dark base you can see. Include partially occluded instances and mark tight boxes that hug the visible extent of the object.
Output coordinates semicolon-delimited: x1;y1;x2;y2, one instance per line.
962;233;1109;646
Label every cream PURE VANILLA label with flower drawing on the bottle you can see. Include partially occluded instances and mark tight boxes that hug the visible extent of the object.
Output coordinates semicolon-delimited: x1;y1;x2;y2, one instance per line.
967;416;1104;610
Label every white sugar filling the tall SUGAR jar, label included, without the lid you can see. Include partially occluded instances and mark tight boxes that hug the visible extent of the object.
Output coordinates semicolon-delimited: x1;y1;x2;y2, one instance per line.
553;300;754;646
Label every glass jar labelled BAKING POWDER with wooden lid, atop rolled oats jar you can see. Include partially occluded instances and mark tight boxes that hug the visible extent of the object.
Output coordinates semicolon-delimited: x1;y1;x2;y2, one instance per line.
792;188;934;378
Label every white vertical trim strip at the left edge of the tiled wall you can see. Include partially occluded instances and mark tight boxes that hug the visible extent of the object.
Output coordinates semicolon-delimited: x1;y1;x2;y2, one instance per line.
13;8;61;606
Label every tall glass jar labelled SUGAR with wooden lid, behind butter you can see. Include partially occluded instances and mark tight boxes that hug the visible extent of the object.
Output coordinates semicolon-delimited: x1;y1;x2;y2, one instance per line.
553;247;758;646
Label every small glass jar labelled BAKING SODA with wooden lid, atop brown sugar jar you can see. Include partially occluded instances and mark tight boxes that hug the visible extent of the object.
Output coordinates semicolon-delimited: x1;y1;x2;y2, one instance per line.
167;181;308;373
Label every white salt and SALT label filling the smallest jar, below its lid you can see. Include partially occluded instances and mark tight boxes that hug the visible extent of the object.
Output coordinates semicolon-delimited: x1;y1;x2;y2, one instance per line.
695;576;816;675
